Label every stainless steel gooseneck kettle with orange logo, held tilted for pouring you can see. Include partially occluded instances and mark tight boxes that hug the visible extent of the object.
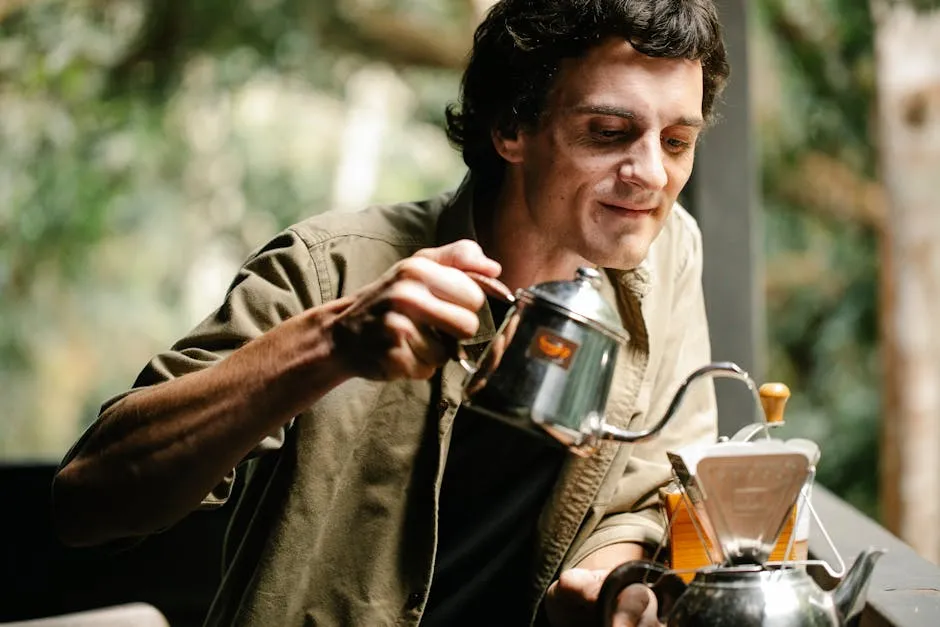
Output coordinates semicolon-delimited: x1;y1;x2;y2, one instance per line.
457;267;756;456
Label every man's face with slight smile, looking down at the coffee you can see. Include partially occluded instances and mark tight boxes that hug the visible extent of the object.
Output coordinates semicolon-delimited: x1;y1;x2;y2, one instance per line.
497;39;703;269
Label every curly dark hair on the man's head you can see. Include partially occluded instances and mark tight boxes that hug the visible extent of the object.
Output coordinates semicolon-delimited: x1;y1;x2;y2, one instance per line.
446;0;730;183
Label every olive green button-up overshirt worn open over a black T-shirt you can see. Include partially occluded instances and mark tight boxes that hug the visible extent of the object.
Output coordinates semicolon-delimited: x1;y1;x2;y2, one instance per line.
84;179;716;627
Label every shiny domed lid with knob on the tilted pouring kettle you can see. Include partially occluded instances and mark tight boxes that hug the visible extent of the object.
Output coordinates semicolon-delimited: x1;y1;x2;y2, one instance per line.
525;266;627;342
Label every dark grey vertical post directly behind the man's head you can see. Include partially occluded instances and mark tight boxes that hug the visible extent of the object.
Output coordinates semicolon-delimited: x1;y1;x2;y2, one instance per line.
682;0;765;435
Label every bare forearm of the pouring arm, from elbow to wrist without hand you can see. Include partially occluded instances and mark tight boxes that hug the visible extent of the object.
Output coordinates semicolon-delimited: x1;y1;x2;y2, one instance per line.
54;301;350;544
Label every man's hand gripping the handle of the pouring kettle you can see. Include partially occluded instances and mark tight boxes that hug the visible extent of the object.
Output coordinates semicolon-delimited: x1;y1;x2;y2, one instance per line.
333;240;501;380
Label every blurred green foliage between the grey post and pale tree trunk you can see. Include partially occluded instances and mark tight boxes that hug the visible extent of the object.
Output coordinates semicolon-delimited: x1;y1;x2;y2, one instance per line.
754;0;882;516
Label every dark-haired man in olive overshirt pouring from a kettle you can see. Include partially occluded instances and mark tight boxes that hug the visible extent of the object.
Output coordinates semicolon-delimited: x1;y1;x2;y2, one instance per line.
54;0;728;627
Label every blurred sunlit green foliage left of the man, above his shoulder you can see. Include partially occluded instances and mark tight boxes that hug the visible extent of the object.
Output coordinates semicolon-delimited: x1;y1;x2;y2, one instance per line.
0;0;462;460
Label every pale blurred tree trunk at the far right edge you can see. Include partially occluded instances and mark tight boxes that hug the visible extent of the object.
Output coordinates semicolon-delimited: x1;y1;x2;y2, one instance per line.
872;0;940;563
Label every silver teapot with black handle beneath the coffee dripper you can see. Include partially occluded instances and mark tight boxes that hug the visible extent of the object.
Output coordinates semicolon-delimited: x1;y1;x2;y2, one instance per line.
598;549;884;627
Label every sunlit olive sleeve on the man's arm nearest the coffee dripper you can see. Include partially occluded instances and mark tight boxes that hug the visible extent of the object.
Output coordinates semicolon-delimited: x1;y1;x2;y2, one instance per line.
567;210;718;566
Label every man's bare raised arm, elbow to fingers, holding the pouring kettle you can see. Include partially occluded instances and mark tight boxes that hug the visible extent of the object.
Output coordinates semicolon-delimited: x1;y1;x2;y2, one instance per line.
53;242;499;545
